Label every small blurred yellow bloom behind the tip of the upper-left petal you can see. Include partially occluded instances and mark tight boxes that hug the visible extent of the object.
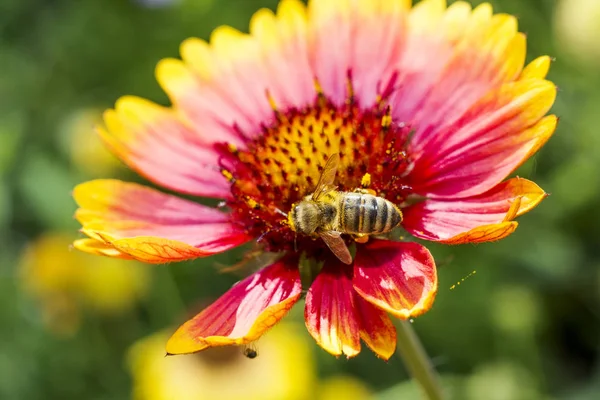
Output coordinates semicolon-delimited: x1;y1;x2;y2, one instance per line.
60;108;121;177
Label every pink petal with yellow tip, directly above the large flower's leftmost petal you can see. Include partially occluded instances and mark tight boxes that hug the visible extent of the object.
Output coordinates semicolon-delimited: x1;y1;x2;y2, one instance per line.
98;96;231;198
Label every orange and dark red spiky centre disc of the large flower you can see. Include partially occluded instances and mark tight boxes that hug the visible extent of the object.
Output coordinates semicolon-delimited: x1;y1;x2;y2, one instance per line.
222;96;410;251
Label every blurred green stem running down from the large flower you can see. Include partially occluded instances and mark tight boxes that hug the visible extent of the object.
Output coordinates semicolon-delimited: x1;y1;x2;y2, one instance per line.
396;321;444;400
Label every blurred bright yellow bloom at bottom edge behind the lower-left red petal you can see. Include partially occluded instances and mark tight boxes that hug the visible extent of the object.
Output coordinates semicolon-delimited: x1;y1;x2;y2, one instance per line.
129;323;316;400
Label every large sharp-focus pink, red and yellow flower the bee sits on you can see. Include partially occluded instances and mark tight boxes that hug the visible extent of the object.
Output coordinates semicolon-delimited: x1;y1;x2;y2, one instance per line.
74;0;557;359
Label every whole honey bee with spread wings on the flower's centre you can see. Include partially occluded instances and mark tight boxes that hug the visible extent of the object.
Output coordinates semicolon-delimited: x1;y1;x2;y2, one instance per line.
287;153;402;264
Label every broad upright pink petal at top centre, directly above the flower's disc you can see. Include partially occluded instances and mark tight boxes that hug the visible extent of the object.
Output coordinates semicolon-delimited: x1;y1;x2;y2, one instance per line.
309;0;410;107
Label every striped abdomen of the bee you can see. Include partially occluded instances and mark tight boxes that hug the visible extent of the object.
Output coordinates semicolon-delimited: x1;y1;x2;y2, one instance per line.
339;192;402;234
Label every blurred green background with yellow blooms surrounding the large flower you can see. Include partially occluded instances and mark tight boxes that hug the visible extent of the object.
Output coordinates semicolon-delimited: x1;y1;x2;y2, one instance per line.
0;0;600;400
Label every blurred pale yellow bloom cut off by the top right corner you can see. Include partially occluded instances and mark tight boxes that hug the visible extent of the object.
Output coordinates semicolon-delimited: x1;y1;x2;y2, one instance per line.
554;0;600;65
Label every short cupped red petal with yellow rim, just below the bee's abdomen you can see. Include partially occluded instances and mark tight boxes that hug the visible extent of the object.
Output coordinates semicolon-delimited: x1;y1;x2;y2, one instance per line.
353;240;438;319
